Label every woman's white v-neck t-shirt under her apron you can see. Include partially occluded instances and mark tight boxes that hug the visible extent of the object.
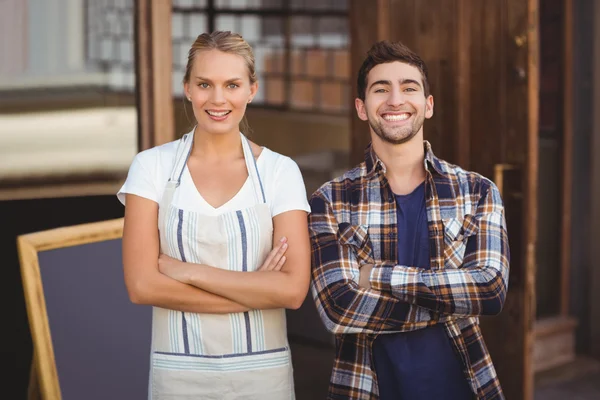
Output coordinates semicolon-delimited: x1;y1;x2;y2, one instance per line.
117;140;310;217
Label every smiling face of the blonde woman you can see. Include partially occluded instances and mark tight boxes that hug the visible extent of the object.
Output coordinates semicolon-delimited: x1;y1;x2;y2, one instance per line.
184;50;258;134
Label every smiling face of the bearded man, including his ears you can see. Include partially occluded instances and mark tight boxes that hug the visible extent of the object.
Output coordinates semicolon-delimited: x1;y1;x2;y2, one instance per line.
355;61;433;144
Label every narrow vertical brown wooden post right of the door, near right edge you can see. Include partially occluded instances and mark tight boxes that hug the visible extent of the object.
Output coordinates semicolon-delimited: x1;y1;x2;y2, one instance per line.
560;0;574;317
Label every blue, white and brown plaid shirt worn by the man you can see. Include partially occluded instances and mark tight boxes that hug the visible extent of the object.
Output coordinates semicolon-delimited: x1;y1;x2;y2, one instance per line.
309;141;509;400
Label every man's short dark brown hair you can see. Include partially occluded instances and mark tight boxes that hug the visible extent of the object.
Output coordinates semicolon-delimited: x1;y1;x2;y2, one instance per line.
357;40;429;101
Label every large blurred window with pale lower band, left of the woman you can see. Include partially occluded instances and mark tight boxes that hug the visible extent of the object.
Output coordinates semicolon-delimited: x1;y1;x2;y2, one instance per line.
0;0;137;194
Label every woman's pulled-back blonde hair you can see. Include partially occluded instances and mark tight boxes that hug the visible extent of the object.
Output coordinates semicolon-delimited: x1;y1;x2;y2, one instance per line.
183;31;257;134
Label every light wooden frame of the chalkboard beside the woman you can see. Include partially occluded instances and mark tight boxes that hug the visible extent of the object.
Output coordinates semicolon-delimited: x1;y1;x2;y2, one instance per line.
17;218;123;400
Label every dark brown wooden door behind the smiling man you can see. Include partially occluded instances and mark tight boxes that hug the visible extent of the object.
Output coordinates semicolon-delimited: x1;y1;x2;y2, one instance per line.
350;0;539;400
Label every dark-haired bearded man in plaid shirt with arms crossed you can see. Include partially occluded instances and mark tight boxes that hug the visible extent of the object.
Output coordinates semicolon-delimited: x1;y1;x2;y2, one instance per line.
309;41;509;400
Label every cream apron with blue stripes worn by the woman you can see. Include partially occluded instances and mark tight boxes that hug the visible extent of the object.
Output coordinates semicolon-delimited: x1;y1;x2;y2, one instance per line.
149;132;295;400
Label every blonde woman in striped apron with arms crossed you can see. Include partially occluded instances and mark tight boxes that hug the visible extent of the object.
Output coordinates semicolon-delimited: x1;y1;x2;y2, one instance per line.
118;32;310;400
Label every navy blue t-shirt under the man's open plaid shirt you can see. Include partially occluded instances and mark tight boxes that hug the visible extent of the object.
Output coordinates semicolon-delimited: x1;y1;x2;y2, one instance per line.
373;183;473;400
